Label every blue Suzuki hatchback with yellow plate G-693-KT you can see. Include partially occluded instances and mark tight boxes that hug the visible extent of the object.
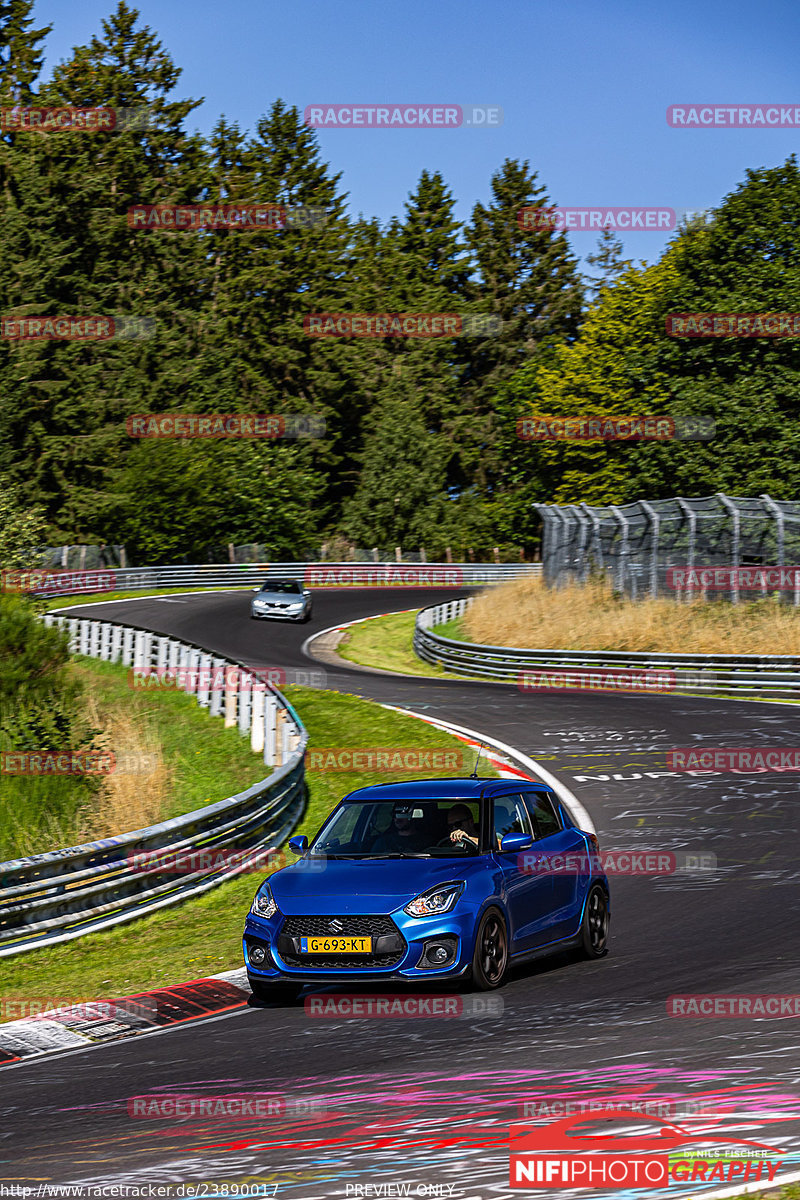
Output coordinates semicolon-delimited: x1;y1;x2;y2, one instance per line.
243;778;609;1000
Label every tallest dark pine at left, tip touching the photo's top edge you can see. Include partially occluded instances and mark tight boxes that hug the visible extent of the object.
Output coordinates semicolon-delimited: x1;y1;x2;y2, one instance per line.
0;4;201;541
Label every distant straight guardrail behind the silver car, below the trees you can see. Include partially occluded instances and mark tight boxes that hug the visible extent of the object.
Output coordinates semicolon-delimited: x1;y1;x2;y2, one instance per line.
21;563;541;596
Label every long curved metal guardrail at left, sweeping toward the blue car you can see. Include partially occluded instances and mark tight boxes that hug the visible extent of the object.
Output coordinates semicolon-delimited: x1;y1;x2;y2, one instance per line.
0;613;308;958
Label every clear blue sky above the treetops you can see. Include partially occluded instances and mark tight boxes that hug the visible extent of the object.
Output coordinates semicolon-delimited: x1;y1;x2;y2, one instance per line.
35;0;800;262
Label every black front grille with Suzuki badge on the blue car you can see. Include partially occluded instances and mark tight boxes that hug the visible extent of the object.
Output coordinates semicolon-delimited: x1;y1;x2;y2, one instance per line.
277;913;408;971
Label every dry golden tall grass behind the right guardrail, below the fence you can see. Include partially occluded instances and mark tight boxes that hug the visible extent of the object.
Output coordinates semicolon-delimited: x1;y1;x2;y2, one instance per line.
464;577;800;654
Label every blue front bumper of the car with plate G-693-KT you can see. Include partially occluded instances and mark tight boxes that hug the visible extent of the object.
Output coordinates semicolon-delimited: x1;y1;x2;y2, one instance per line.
242;911;476;983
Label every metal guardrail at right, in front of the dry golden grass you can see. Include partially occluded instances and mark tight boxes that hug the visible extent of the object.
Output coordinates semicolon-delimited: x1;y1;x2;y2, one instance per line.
414;596;800;700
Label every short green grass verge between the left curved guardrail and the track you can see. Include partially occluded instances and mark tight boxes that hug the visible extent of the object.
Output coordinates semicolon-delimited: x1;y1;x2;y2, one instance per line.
0;688;488;1002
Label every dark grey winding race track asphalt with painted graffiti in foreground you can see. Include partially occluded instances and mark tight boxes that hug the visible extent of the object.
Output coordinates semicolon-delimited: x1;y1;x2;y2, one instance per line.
0;588;800;1200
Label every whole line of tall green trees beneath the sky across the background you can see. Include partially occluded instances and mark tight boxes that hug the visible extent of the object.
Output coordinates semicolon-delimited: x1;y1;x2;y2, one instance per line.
0;0;800;564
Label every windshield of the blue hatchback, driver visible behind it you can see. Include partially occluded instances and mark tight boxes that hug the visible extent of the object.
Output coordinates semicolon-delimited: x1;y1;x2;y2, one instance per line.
311;799;480;858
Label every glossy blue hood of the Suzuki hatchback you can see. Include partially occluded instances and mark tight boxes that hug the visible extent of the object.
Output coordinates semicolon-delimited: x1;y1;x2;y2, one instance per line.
270;856;486;916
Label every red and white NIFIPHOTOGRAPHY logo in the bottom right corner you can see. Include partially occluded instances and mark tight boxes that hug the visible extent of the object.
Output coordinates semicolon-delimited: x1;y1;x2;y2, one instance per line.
509;1108;786;1190
